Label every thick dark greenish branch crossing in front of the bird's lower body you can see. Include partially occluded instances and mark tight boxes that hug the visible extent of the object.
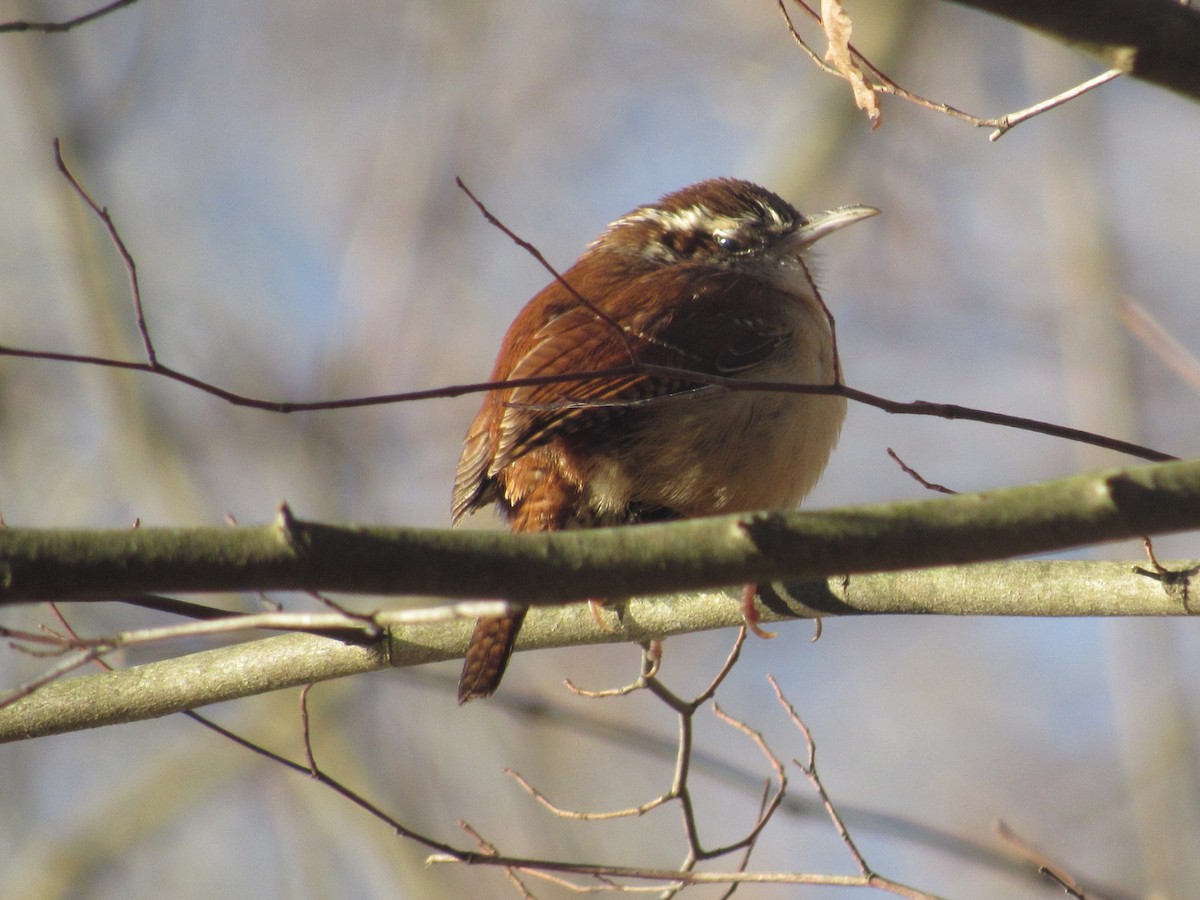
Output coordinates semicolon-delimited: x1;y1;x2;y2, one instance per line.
0;461;1200;604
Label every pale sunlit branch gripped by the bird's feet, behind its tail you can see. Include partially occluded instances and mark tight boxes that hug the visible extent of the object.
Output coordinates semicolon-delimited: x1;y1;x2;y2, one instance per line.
0;560;1193;742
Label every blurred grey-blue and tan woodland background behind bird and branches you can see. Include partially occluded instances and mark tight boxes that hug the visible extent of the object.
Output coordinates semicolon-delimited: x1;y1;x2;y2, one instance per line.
0;0;1200;898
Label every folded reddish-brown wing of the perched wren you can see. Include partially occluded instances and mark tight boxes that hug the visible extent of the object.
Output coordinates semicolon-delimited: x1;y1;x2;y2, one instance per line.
452;264;791;521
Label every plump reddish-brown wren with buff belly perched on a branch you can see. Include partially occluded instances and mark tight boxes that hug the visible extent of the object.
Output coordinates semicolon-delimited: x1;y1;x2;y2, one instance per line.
451;178;878;703
